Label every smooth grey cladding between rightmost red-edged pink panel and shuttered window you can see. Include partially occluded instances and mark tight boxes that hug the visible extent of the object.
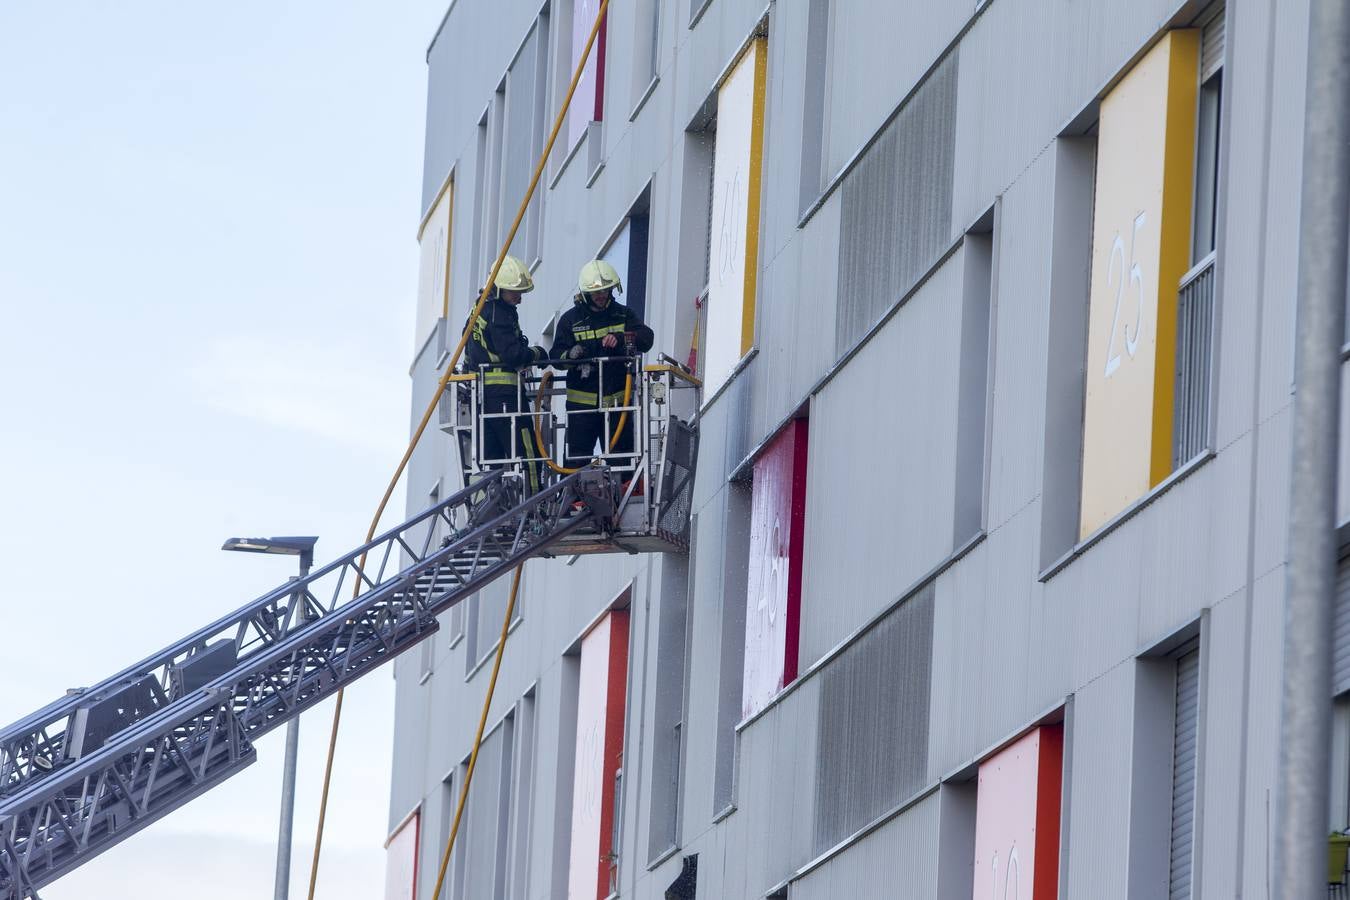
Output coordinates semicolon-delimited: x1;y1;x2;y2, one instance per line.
1064;660;1135;900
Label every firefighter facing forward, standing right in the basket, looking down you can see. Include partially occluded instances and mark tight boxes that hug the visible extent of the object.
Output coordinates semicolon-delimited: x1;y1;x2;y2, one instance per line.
554;259;655;466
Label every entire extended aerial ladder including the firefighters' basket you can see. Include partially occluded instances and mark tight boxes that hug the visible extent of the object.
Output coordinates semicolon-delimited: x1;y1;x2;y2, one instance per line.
0;360;698;900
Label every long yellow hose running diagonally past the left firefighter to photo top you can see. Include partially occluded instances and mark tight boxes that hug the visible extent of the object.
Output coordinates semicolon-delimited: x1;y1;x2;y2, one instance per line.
306;0;609;900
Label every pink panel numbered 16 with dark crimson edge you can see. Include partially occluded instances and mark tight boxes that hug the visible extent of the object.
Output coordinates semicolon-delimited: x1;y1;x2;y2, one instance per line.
741;418;807;716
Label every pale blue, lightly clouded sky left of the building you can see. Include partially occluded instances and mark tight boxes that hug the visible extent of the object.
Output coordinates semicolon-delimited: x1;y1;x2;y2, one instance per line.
0;0;447;900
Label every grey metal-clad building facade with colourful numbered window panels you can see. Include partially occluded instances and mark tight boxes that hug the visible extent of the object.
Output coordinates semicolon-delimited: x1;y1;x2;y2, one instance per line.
389;0;1350;900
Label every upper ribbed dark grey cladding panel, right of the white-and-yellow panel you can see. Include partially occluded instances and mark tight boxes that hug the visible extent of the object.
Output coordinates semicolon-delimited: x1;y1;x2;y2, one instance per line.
834;53;957;355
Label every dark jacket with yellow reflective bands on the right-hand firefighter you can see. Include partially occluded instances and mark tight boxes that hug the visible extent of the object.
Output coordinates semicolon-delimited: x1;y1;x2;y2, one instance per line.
551;297;656;409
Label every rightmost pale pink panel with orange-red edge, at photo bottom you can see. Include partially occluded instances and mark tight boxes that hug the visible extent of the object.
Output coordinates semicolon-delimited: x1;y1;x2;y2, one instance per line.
973;725;1064;900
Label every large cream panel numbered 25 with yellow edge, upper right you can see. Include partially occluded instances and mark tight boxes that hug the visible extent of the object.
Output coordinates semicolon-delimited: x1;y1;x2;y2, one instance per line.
1080;28;1200;537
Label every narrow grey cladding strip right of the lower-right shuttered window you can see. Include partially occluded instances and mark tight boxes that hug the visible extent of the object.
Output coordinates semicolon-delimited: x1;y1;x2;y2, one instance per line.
1195;594;1246;897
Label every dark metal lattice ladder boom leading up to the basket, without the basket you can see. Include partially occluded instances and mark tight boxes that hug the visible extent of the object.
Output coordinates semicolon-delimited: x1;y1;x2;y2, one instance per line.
0;467;617;900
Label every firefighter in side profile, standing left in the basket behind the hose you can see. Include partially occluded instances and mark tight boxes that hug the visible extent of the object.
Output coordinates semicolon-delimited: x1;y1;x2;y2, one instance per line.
464;256;548;493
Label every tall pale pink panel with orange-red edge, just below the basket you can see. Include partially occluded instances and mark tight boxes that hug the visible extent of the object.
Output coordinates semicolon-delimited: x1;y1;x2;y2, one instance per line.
567;610;628;900
